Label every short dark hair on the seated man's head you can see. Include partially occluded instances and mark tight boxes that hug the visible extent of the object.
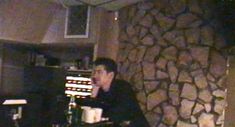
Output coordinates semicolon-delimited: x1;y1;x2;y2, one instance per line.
94;57;117;75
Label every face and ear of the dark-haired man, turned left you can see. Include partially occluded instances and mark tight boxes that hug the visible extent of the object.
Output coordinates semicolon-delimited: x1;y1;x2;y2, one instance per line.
92;65;114;87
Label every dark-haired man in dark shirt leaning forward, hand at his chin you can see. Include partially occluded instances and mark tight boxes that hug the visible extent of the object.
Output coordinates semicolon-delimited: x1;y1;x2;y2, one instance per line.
92;58;149;127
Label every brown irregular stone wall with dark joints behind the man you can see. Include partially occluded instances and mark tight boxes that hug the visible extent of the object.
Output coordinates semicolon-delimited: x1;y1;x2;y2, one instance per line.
118;0;226;127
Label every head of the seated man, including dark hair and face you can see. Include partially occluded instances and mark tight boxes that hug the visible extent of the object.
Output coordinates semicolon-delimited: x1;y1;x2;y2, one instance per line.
92;58;117;90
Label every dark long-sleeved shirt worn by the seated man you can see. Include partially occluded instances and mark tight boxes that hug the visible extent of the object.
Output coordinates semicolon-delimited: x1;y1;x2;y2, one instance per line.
93;80;149;127
